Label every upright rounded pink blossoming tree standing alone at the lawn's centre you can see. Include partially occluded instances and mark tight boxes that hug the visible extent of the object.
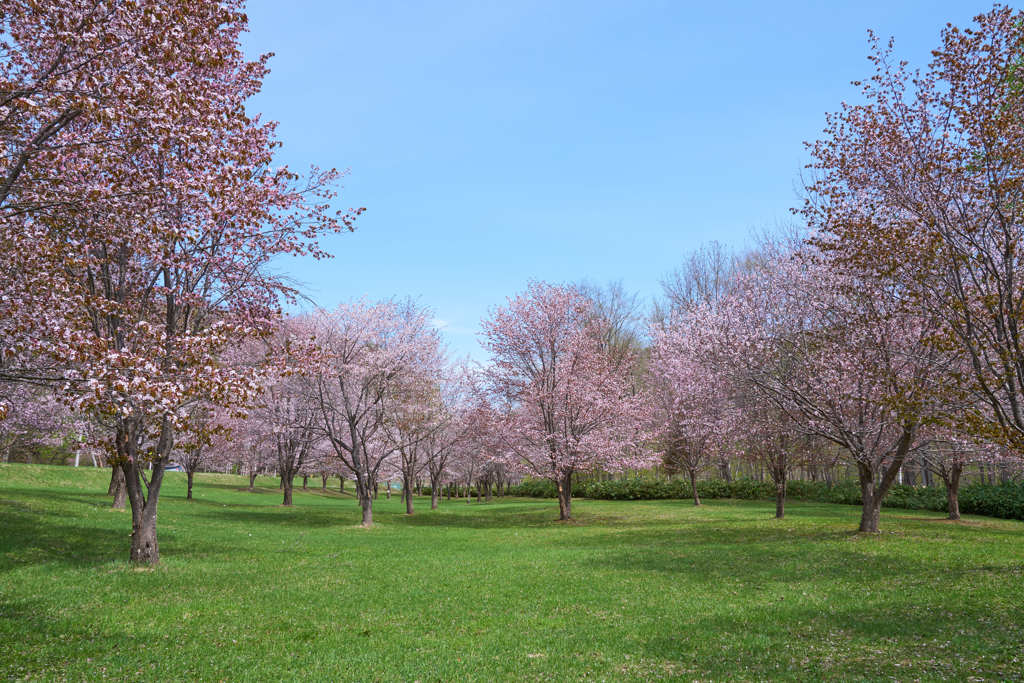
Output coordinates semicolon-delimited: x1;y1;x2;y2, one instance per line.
481;283;647;519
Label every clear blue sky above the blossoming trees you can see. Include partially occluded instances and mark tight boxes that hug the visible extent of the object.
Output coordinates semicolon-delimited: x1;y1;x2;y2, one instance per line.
239;0;991;357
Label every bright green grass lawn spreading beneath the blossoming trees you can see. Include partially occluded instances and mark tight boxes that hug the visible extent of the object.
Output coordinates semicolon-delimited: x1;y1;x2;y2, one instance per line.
0;465;1024;681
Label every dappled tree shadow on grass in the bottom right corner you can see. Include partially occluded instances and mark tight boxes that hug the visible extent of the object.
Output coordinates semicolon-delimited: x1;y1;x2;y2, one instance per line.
642;592;1024;680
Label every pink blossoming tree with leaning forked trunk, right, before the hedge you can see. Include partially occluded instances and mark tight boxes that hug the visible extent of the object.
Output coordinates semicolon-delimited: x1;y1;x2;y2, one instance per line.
704;251;947;531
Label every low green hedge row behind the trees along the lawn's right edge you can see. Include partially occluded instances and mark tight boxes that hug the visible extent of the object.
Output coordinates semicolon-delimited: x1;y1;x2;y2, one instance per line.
508;479;1024;519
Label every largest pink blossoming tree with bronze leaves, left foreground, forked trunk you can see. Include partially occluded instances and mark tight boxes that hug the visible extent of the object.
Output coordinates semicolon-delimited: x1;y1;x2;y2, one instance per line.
0;0;357;564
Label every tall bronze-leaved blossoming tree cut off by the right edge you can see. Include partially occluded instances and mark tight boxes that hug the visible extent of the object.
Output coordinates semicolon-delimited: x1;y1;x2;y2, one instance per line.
802;5;1024;450
